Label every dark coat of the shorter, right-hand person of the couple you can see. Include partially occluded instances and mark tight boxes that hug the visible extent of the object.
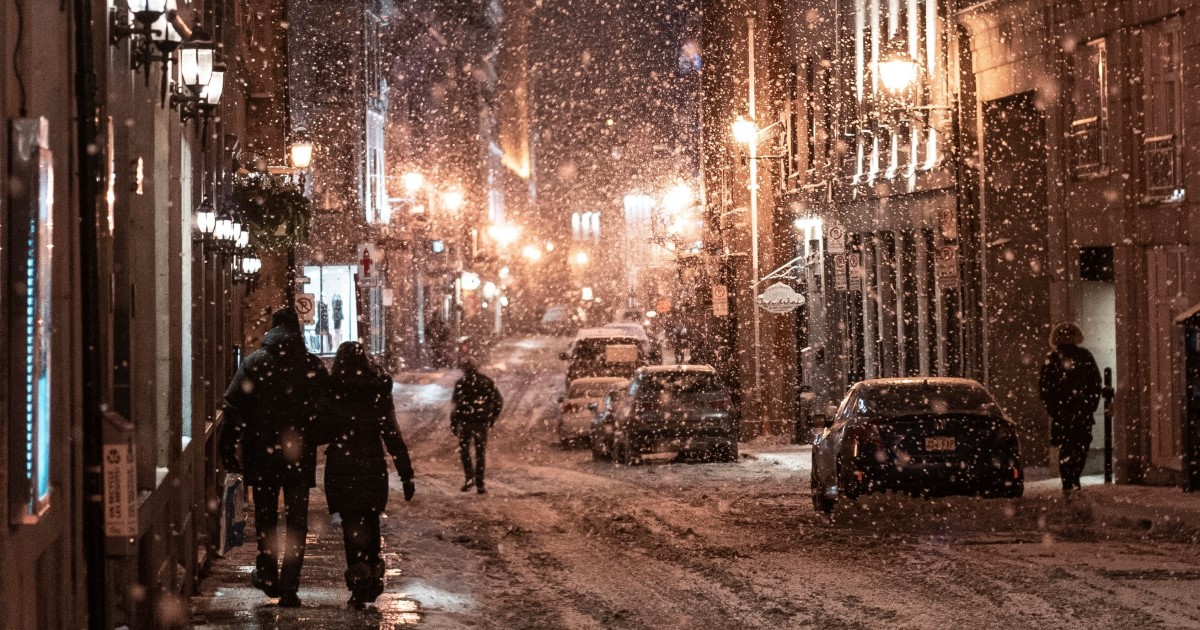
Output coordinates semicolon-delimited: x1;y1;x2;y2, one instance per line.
325;374;413;514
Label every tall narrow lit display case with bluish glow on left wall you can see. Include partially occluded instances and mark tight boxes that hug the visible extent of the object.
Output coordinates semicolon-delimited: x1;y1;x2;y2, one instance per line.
6;119;54;523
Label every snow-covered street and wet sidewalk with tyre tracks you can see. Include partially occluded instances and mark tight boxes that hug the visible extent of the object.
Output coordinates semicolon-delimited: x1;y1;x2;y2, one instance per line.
193;338;1200;630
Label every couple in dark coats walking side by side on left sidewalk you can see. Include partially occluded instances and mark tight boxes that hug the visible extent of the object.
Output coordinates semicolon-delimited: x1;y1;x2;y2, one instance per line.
220;308;415;608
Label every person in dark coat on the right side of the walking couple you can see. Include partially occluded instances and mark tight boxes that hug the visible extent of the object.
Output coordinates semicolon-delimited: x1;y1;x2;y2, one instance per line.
324;341;415;608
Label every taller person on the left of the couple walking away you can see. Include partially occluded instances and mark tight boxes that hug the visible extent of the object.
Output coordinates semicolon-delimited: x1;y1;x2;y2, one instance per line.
220;308;328;606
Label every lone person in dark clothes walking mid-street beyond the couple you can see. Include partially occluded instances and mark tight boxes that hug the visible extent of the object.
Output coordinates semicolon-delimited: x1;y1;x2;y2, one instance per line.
450;359;504;494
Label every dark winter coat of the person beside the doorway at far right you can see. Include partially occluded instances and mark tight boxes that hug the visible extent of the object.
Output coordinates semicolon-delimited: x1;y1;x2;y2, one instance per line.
1038;344;1100;445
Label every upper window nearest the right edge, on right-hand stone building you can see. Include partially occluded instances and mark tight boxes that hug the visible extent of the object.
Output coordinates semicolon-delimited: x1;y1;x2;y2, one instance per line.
1142;17;1183;199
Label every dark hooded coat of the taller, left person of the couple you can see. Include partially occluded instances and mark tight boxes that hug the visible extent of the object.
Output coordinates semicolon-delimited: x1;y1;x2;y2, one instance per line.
220;326;329;487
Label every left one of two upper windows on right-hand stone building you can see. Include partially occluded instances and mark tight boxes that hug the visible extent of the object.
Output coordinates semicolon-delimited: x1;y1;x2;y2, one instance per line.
1067;40;1109;178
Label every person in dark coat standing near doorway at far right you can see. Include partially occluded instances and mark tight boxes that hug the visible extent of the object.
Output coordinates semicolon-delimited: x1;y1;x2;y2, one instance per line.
1038;323;1100;494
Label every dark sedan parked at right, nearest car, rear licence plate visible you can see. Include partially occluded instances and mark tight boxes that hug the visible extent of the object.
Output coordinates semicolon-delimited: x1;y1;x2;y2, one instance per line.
812;378;1025;512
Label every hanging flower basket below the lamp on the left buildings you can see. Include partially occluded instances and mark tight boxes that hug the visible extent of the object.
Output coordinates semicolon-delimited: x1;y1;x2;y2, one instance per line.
233;173;312;251
